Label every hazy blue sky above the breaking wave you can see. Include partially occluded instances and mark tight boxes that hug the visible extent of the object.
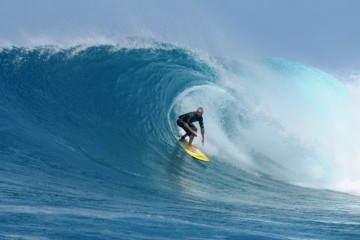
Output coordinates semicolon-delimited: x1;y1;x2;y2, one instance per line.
0;0;360;72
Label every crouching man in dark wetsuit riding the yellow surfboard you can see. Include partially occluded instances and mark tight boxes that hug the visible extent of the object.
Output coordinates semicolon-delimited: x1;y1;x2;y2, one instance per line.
176;107;205;147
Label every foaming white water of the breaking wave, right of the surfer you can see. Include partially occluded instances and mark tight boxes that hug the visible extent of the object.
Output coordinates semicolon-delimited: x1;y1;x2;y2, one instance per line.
175;59;360;194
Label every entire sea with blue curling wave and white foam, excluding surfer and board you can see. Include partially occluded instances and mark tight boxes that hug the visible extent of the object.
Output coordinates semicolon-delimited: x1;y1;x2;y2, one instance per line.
0;43;360;239
